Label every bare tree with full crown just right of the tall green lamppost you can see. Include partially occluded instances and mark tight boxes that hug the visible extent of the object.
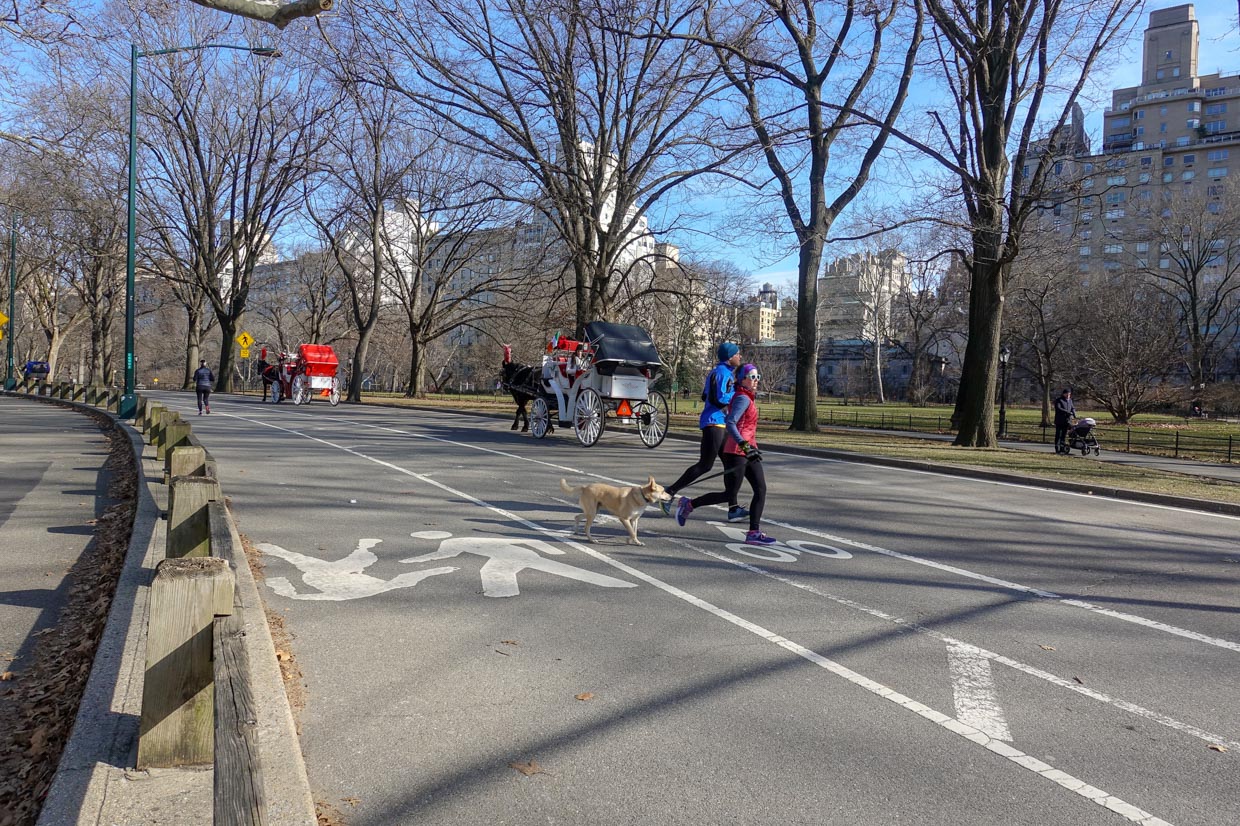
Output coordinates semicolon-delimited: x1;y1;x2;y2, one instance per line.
139;21;322;392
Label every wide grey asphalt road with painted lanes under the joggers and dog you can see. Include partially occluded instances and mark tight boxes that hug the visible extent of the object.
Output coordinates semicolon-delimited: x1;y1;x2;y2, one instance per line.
153;393;1240;826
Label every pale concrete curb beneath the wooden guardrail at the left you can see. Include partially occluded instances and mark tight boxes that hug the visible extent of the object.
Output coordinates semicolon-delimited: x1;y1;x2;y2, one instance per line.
14;393;317;826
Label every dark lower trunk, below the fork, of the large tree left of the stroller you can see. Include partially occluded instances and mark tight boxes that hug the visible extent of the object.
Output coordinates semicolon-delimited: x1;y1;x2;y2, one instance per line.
952;257;1004;448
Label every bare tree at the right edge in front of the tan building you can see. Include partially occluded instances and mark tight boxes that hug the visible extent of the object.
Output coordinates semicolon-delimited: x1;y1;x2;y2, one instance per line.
1125;179;1240;393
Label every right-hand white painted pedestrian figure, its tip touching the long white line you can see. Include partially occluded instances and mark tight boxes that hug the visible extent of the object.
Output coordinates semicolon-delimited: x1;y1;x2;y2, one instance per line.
401;531;637;597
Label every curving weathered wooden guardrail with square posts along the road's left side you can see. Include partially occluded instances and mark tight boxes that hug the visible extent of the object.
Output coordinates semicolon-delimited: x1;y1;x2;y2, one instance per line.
17;380;267;826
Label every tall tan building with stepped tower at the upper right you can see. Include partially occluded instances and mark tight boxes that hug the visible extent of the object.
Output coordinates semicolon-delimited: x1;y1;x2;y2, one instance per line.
1041;4;1240;278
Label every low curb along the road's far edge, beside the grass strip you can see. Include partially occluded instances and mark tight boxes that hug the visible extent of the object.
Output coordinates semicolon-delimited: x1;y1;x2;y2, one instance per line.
352;402;1240;516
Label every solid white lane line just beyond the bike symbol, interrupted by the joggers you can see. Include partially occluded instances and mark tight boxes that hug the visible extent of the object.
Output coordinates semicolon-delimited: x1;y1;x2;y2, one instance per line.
188;399;1240;652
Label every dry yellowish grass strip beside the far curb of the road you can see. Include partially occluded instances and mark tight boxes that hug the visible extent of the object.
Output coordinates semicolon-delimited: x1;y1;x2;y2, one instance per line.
363;394;1240;504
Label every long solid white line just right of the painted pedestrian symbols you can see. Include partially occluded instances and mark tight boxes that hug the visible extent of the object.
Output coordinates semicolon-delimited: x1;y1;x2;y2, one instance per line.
188;406;1171;826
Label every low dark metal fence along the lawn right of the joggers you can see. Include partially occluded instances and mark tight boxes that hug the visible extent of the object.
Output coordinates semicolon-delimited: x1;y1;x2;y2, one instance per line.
763;407;1240;463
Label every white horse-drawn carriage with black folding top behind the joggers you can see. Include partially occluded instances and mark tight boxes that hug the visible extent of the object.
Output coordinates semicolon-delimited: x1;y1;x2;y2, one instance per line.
510;321;668;448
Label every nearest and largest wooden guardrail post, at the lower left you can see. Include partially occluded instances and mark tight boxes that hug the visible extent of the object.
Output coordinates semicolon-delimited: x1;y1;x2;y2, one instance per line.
138;558;233;769
